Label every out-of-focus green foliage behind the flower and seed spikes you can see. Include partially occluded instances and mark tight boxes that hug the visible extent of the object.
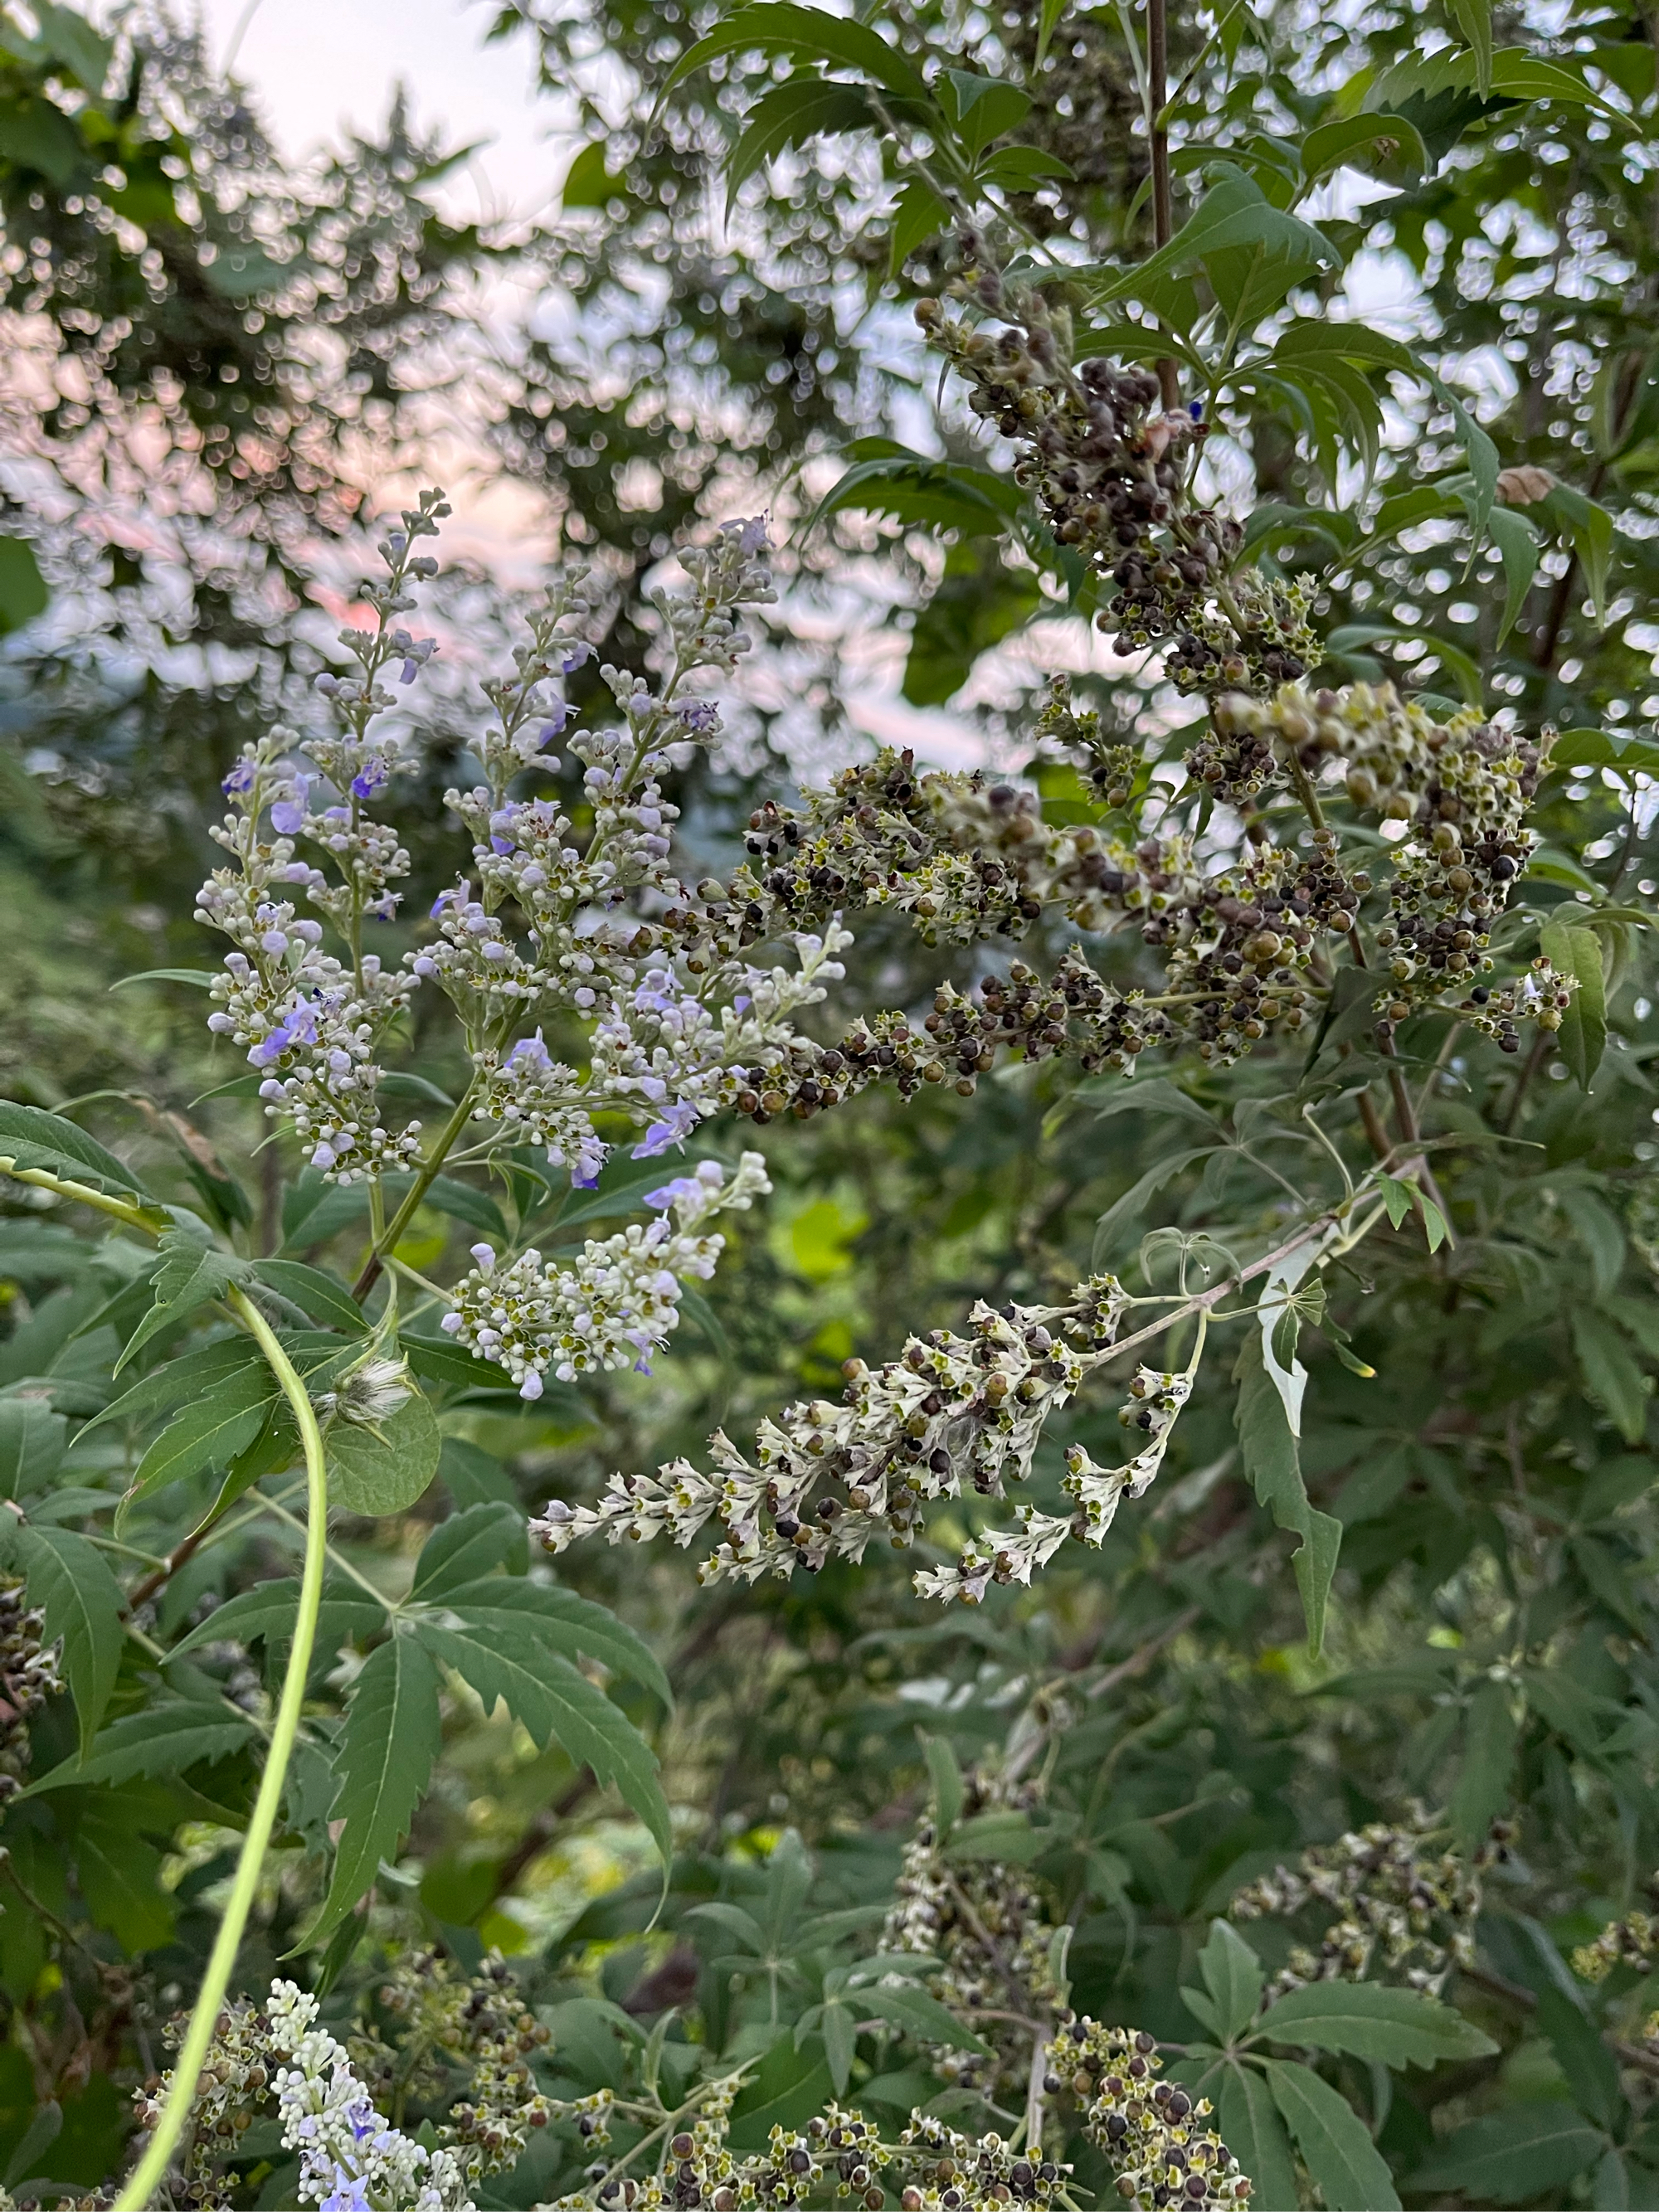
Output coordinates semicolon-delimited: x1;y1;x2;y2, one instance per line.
0;0;1659;2205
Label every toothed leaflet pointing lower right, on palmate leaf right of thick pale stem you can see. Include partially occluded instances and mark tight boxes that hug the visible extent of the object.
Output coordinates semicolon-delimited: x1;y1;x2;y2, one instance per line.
413;1610;673;1864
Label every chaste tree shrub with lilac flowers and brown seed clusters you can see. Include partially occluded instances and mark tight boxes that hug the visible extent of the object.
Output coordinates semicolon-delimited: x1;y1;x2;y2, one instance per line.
0;0;1659;2212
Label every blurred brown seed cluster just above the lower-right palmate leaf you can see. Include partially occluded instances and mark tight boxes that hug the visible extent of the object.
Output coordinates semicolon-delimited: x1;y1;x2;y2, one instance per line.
1228;1805;1521;1997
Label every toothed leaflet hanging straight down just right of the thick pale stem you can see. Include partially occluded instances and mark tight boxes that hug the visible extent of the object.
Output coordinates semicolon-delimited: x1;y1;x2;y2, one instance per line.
305;1637;442;1947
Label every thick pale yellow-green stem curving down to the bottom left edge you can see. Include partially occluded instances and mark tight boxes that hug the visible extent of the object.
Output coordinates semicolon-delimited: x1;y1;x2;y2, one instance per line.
115;1287;328;2212
